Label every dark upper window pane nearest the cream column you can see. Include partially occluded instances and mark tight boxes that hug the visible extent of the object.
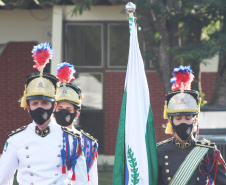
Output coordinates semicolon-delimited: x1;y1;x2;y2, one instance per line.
65;23;102;67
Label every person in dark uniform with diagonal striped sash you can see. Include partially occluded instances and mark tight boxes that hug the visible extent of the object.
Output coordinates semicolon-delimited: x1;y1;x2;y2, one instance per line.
157;66;226;185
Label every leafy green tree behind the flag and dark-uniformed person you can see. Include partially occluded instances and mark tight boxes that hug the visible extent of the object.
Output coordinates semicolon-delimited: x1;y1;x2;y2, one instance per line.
71;0;226;105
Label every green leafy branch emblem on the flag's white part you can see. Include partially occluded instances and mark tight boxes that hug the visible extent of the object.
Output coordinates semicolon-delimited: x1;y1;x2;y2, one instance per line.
127;146;140;185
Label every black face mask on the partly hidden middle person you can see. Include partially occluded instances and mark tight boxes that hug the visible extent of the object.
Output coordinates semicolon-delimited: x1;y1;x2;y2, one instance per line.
54;109;77;127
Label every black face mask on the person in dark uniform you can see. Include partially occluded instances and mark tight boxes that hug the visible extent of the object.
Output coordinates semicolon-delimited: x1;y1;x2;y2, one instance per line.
172;123;193;140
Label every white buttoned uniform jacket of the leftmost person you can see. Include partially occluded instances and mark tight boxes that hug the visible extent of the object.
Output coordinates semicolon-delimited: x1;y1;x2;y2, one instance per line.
0;119;88;185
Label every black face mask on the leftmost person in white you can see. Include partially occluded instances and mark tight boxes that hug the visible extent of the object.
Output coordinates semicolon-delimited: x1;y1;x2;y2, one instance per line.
30;105;54;125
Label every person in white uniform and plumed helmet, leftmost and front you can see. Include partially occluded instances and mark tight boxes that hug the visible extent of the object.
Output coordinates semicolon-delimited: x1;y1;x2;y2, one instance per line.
0;43;88;185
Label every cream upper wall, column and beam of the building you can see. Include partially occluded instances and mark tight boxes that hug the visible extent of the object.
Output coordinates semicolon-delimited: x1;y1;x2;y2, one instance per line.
0;5;218;74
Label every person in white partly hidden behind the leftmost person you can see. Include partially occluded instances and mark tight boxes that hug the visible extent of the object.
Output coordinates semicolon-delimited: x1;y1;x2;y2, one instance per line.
54;62;98;185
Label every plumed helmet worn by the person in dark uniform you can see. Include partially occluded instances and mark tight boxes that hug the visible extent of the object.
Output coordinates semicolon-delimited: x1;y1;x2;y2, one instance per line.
163;66;201;119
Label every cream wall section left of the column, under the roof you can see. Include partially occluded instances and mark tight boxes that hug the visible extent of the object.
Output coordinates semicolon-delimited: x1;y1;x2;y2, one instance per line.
0;9;52;44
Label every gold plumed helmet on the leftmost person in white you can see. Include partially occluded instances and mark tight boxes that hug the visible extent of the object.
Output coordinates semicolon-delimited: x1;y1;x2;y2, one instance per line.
20;43;59;108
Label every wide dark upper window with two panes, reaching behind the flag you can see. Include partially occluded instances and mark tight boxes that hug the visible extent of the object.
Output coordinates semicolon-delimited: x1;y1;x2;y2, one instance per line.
64;21;144;68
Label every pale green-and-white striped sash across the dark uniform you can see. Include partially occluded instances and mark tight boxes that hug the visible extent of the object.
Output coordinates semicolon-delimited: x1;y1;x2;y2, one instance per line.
169;146;209;185
